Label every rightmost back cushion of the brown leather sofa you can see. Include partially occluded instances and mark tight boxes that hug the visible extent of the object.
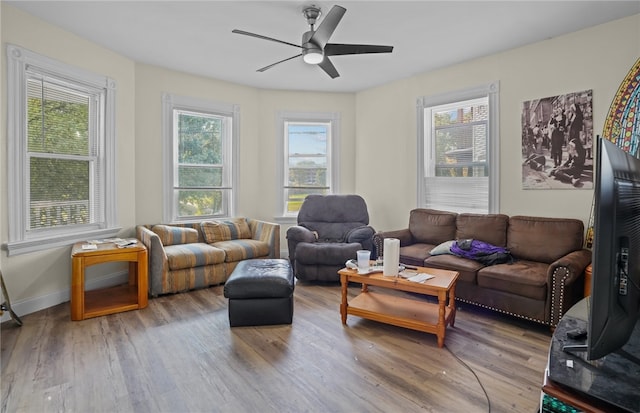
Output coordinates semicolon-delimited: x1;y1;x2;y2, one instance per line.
507;216;584;264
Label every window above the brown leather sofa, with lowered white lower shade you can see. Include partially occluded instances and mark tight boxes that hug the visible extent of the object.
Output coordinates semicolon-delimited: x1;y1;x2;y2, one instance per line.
418;83;499;213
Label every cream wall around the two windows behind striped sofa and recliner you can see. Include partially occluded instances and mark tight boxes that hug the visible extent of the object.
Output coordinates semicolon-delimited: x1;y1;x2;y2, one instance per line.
135;70;355;225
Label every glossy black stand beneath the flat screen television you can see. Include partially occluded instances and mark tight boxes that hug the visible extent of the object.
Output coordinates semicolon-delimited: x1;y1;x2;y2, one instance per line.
543;298;640;412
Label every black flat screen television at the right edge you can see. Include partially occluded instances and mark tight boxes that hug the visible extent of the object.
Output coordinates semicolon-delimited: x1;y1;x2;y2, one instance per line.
584;137;640;360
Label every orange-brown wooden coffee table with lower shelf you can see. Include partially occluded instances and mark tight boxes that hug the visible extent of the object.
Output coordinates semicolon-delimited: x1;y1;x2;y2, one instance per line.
338;267;458;348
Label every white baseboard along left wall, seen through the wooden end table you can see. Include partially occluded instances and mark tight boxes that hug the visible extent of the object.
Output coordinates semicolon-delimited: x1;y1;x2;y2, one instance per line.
0;271;129;323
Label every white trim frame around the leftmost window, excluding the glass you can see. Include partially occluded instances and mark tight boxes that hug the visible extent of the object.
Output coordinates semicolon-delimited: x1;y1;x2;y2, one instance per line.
5;44;121;255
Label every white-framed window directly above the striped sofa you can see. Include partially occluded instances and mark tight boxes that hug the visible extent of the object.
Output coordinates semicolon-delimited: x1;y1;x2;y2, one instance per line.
163;94;239;222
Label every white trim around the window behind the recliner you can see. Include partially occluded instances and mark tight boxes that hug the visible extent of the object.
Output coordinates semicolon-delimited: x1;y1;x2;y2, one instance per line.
274;112;340;224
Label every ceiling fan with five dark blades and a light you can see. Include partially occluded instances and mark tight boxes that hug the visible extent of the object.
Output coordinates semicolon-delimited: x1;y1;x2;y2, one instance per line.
232;5;393;79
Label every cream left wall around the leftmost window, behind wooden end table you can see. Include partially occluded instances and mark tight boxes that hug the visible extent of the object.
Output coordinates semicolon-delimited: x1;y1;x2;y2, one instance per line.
0;3;136;316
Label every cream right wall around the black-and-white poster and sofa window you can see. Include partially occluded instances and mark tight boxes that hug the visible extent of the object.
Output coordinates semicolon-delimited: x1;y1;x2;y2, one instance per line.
356;15;640;230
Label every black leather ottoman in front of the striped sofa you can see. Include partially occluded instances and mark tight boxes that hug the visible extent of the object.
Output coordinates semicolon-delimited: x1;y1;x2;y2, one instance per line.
224;259;294;327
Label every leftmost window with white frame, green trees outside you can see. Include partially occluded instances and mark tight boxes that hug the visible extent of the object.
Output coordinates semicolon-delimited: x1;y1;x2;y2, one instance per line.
7;45;119;254
